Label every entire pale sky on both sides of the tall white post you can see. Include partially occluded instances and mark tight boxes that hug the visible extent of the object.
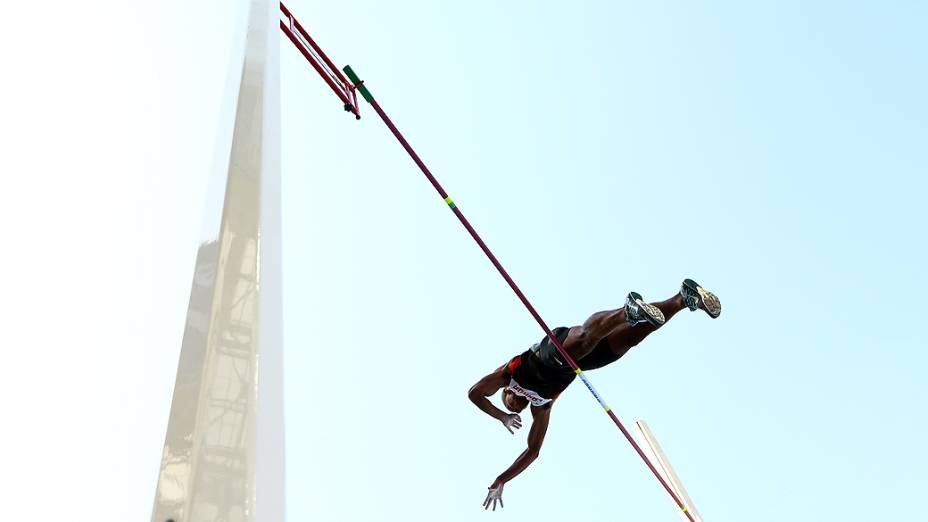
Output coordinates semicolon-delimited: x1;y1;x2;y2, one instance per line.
0;0;928;522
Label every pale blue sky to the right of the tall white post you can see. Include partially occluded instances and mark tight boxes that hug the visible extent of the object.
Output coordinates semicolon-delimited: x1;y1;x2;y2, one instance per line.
283;2;928;521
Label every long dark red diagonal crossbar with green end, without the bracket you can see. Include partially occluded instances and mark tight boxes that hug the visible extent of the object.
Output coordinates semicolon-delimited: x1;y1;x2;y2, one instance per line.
344;66;696;522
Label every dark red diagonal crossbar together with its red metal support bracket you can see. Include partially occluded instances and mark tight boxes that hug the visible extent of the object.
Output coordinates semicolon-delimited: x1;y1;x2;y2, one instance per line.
281;4;696;522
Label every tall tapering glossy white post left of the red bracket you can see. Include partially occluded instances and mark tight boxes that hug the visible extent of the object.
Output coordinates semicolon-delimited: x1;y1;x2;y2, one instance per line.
152;0;285;522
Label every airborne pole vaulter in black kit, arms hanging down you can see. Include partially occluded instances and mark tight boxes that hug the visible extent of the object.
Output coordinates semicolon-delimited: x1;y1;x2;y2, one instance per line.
468;279;722;511
